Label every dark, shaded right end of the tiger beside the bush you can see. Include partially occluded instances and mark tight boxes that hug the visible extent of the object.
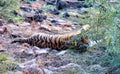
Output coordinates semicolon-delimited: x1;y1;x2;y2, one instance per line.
66;37;90;52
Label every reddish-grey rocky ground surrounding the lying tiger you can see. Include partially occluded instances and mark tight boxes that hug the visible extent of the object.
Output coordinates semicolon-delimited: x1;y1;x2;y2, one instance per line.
0;0;119;74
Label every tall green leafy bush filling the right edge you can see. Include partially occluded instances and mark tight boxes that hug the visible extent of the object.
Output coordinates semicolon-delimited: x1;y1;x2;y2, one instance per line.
85;0;120;71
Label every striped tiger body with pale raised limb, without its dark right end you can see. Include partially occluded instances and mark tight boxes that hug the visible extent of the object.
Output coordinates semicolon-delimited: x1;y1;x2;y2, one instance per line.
11;25;90;50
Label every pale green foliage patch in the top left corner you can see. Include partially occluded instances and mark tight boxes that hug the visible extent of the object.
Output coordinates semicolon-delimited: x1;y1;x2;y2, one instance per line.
0;0;20;20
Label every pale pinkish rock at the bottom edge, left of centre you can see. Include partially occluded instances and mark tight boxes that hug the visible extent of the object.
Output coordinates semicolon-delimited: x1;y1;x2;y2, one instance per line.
16;59;45;74
